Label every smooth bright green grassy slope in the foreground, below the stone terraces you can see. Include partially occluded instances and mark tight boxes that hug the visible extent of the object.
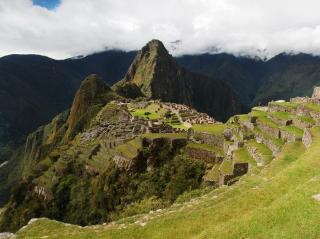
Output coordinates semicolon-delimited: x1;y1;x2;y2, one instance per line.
17;127;320;239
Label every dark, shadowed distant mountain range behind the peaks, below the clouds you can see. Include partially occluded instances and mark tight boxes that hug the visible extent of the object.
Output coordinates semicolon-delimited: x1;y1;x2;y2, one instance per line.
0;41;320;162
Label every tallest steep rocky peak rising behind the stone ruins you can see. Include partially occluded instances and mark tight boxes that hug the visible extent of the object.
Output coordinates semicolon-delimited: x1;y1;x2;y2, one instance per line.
116;40;192;103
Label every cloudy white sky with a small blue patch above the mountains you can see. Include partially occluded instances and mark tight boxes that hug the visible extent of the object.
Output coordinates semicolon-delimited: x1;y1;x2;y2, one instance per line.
0;0;320;59
